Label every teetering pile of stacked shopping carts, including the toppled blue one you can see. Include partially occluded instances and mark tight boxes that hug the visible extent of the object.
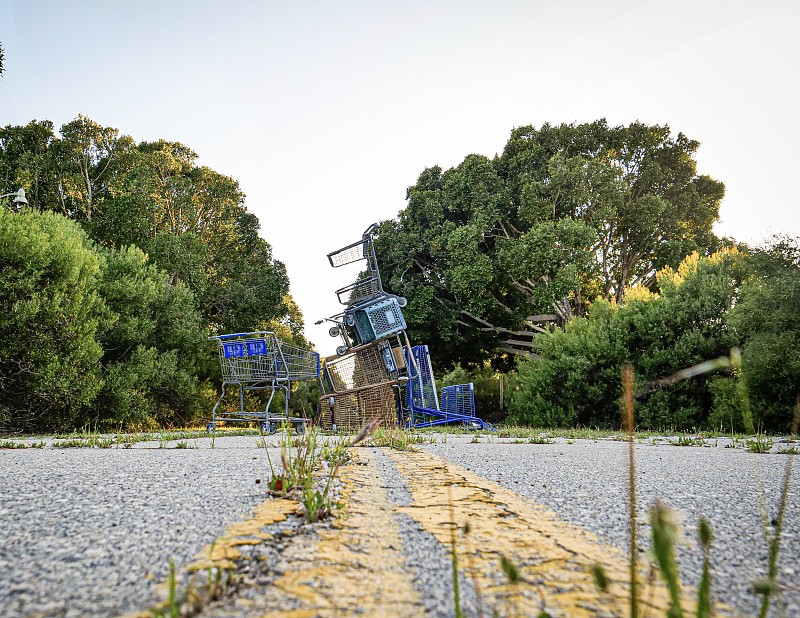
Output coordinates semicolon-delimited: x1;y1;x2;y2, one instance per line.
318;225;484;431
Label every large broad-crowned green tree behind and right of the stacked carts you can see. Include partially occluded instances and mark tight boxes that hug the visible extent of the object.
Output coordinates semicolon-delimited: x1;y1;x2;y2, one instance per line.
377;120;724;365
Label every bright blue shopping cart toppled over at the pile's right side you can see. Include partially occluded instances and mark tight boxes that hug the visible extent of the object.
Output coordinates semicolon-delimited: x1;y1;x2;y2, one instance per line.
401;345;494;430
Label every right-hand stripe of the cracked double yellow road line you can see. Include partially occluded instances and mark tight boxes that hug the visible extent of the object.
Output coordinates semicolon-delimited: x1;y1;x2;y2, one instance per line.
386;450;696;617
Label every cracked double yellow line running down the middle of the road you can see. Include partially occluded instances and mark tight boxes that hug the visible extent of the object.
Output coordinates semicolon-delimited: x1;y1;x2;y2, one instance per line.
144;449;722;618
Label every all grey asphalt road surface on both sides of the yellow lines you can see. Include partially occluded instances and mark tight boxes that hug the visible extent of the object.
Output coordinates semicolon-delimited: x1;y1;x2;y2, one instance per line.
0;435;800;617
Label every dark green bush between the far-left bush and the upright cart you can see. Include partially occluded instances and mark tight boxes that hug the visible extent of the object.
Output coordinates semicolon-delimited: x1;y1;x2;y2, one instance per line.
93;247;208;428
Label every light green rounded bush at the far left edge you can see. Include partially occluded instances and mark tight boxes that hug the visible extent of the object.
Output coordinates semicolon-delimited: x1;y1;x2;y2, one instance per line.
0;209;108;431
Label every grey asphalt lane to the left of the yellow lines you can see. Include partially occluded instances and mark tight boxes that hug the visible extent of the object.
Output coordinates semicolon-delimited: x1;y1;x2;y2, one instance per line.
0;437;280;618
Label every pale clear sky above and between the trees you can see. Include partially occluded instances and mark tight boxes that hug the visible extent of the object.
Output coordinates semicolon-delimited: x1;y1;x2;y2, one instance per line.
0;0;800;354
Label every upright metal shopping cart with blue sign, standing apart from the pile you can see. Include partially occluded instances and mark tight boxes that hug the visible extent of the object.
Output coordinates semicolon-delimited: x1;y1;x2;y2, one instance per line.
206;331;320;433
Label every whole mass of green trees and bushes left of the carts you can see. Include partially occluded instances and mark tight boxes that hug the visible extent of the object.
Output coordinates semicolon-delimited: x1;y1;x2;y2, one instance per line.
0;116;316;434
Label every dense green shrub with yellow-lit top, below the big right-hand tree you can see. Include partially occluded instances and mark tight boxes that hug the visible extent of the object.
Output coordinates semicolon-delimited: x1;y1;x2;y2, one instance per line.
509;251;740;429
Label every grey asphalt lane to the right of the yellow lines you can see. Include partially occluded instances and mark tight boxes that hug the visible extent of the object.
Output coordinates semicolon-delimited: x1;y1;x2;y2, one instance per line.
426;436;800;616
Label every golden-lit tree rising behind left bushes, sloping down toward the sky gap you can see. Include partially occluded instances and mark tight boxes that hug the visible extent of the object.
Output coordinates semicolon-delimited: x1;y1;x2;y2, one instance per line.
87;140;289;332
